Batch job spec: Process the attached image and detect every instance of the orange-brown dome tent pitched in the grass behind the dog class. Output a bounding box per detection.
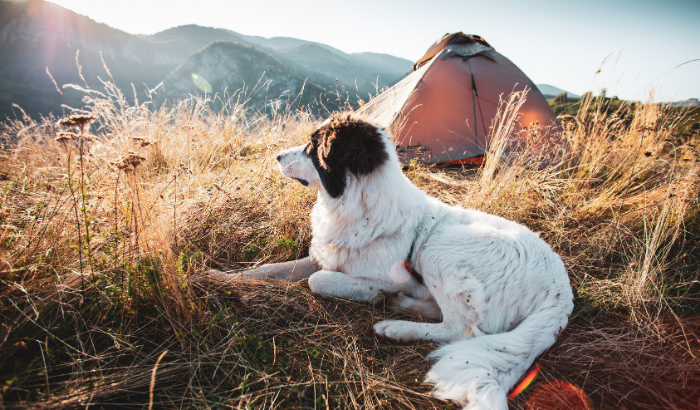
[358,32,560,164]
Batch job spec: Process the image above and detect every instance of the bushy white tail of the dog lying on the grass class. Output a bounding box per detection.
[425,301,573,410]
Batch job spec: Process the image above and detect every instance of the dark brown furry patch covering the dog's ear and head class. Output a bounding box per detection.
[306,114,389,198]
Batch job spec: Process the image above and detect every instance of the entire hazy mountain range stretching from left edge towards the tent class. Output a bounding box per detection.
[0,0,412,121]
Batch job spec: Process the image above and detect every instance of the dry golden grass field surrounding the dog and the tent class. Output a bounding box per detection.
[0,78,700,409]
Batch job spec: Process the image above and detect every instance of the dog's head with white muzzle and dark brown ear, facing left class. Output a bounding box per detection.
[277,114,389,198]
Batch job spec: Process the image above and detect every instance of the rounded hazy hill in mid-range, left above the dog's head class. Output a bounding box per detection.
[163,41,323,108]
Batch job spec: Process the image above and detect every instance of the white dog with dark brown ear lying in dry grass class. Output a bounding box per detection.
[246,114,573,409]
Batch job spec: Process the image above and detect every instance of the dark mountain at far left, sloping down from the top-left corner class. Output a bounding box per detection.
[0,0,178,118]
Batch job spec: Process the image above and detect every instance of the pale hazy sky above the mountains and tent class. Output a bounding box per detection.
[53,0,700,101]
